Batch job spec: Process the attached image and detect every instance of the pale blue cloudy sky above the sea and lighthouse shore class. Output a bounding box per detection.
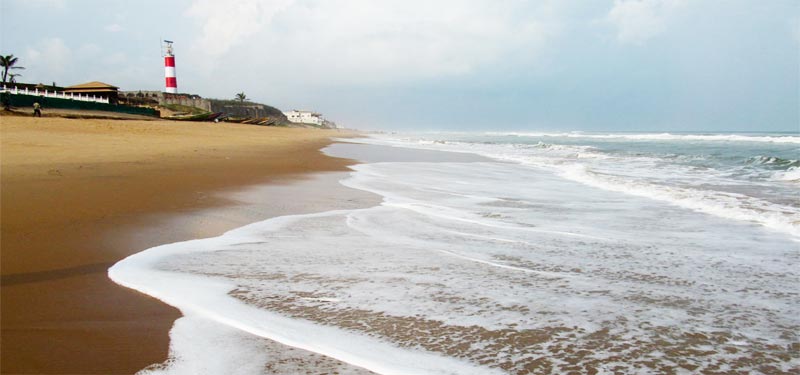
[0,0,800,132]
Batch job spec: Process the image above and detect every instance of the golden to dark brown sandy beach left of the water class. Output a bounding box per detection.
[0,116,358,374]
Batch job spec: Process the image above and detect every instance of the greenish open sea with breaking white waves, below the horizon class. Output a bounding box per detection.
[344,133,800,238]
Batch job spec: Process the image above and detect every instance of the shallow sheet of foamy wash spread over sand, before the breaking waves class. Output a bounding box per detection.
[109,142,800,374]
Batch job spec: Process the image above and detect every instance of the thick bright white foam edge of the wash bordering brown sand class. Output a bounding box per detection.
[108,210,501,375]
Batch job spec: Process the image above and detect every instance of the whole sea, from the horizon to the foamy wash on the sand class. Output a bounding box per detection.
[109,133,800,374]
